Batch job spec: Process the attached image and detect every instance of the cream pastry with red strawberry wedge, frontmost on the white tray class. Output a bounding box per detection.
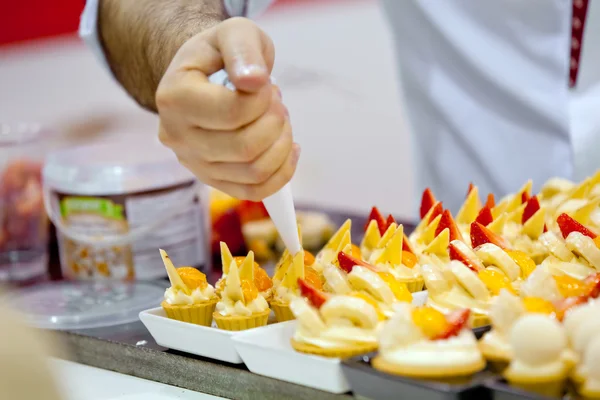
[290,279,382,358]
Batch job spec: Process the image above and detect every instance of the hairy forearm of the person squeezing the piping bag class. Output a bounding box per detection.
[98,0,225,111]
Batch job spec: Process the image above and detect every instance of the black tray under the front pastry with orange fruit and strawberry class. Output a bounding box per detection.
[342,353,492,400]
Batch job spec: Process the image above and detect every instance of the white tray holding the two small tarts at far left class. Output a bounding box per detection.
[140,307,246,364]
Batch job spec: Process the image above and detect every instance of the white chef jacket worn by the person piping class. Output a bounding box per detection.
[81,0,600,211]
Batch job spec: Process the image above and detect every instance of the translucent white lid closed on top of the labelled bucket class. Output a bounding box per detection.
[43,138,195,196]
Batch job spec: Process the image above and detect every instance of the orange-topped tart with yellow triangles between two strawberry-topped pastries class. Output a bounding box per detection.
[369,223,425,293]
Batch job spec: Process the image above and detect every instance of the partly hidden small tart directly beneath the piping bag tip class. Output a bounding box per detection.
[269,251,308,322]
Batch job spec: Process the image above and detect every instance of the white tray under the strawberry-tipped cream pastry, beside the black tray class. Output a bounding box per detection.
[232,291,427,393]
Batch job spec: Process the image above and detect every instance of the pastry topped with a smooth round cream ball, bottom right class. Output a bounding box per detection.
[504,314,571,397]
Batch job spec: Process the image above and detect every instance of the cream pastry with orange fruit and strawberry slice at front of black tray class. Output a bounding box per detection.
[372,304,485,381]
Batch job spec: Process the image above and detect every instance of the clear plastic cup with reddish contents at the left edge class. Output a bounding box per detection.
[0,123,49,282]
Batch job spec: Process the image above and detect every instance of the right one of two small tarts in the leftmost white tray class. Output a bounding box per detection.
[213,251,271,331]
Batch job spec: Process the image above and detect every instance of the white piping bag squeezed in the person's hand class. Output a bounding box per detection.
[208,69,302,255]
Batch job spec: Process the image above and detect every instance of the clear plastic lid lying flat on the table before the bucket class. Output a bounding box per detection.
[7,282,166,330]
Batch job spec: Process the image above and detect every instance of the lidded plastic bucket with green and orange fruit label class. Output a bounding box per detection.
[43,140,209,280]
